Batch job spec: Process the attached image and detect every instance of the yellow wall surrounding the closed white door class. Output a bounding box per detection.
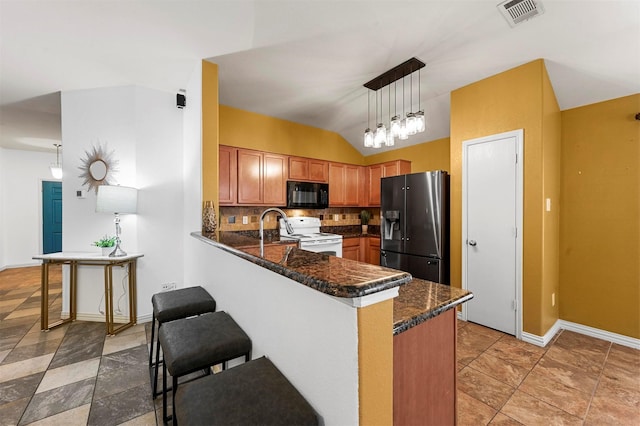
[450,60,557,335]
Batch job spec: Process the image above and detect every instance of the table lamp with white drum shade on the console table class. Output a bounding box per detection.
[96,185,138,257]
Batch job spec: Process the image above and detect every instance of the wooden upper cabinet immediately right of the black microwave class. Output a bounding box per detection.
[329,163,365,207]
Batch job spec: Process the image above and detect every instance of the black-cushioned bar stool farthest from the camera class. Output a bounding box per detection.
[149,286,216,399]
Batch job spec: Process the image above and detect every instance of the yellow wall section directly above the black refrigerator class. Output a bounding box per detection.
[365,138,449,173]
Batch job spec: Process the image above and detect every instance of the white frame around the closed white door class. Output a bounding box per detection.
[460,129,524,340]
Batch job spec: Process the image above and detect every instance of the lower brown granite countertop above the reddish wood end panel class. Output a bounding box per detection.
[393,278,473,335]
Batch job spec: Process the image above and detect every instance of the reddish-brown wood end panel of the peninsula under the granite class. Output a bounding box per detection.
[393,309,457,426]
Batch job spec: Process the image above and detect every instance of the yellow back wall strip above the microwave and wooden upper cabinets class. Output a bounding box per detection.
[220,105,364,164]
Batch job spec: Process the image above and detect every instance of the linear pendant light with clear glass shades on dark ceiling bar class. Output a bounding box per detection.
[364,58,425,148]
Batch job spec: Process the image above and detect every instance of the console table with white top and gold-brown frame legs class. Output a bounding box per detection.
[33,252,144,335]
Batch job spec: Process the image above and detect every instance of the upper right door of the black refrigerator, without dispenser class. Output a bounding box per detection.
[404,171,448,258]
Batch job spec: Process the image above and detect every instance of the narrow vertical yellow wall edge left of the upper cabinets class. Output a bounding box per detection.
[202,61,220,209]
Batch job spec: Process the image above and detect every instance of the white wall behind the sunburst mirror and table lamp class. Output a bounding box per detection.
[61,86,183,319]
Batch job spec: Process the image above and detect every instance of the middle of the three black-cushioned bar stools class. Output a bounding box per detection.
[158,311,251,423]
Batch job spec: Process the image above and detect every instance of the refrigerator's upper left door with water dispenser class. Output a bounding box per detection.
[380,176,406,252]
